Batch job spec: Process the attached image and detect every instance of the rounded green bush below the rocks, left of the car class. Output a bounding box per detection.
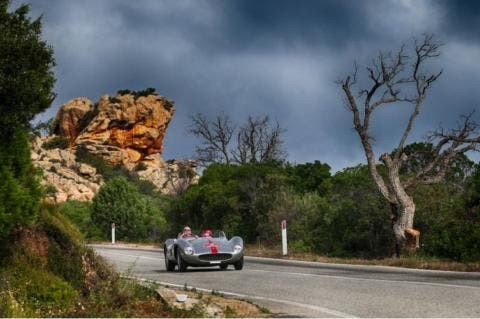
[91,177,165,241]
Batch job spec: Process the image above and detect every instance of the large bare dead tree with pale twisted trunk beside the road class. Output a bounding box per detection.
[338,35,480,255]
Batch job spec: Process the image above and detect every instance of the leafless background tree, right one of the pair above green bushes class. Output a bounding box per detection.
[233,116,286,164]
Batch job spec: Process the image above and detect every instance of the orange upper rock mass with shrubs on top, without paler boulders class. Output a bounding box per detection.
[57,94,175,165]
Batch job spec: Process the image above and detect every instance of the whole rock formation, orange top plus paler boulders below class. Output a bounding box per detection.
[32,91,198,202]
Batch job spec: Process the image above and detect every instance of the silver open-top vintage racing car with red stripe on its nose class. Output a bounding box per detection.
[163,231,243,272]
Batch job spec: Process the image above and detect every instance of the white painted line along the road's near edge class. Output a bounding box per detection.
[125,276,358,318]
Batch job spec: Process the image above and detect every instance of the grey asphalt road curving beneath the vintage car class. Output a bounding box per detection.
[93,245,480,317]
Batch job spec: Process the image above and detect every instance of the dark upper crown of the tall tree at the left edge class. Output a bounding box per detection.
[0,1,55,136]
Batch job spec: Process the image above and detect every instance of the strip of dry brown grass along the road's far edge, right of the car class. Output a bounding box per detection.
[245,245,480,271]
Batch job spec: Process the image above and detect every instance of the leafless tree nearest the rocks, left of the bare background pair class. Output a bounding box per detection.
[188,113,236,166]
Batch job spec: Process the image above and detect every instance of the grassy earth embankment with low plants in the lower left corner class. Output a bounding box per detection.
[0,204,182,317]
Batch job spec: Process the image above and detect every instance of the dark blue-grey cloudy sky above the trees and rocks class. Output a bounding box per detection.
[11,0,480,170]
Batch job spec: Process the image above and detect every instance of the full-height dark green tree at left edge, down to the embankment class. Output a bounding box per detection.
[0,0,55,238]
